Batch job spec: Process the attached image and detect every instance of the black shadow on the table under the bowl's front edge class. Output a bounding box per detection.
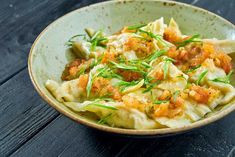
[83,114,235,156]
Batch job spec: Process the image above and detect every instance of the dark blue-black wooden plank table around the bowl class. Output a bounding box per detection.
[0,0,235,157]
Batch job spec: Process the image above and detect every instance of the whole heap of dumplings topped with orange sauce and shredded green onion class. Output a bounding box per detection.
[45,18,235,129]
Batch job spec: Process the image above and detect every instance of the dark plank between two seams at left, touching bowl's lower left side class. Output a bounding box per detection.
[0,69,58,156]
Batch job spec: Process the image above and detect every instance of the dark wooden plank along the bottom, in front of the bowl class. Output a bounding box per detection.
[9,113,235,157]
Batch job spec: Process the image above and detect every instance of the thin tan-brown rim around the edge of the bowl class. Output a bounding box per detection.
[28,0,235,135]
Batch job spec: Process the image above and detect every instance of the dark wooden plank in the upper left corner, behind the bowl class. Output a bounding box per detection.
[0,0,103,85]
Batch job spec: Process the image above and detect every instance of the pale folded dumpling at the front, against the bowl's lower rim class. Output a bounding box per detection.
[65,101,162,129]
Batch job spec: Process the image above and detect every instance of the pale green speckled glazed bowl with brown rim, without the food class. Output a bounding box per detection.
[28,0,235,136]
